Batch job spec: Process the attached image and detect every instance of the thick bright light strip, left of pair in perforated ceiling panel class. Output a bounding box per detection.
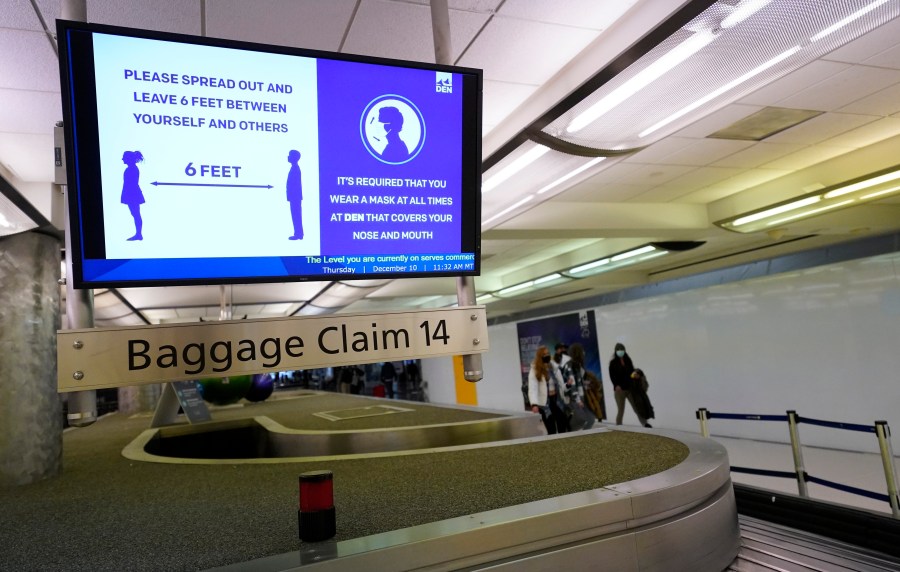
[566,31,716,133]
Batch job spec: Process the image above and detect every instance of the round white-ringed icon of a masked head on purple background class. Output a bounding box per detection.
[359,95,425,165]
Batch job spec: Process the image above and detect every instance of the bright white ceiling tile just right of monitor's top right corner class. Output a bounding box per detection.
[459,16,598,84]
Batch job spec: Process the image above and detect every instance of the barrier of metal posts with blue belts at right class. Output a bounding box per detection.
[697,407,900,519]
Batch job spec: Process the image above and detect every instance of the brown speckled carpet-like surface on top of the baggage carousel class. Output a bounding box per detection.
[0,394,687,571]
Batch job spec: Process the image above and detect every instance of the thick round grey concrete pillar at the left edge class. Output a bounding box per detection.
[0,232,63,486]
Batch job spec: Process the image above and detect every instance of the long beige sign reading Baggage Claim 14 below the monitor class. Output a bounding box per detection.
[57,306,488,392]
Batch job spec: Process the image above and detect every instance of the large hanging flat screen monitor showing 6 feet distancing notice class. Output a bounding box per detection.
[57,21,482,288]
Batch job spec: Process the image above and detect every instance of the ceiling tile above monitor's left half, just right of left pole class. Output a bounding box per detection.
[87,0,200,35]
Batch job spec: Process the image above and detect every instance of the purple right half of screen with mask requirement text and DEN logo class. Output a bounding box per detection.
[317,60,462,255]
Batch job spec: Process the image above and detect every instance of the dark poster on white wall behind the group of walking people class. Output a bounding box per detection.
[516,310,606,419]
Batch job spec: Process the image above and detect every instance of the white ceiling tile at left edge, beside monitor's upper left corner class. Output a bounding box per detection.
[0,29,59,92]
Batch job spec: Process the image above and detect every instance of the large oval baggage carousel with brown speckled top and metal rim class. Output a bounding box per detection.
[0,392,740,572]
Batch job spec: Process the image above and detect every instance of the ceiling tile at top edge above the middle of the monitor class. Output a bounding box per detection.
[206,0,356,52]
